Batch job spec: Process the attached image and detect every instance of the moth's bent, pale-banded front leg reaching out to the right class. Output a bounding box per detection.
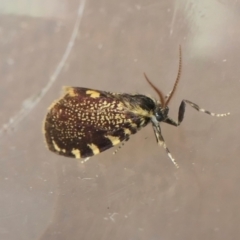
[164,99,230,126]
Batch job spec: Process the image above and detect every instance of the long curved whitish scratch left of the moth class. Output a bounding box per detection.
[0,0,86,136]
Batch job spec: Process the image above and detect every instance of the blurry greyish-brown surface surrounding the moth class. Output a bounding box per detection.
[0,0,240,240]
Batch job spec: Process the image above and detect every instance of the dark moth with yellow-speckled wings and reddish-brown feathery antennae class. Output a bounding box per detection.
[44,48,230,167]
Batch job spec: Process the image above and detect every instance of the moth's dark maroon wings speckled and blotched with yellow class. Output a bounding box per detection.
[44,87,150,158]
